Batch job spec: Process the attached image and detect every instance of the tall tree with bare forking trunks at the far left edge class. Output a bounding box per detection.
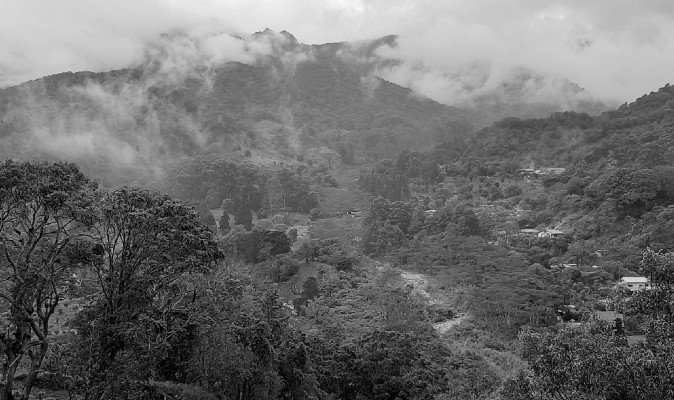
[0,161,96,400]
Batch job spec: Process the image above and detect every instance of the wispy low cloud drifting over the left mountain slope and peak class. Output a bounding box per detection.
[0,27,320,183]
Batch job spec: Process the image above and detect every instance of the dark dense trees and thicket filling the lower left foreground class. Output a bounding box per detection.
[0,161,498,399]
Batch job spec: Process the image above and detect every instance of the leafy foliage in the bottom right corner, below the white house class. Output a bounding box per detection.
[505,250,674,399]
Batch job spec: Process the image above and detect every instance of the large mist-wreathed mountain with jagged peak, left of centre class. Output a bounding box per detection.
[0,30,474,186]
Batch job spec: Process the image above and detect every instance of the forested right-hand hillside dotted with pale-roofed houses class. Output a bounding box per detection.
[350,86,674,399]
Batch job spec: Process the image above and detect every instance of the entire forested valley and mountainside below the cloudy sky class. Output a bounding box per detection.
[0,24,674,400]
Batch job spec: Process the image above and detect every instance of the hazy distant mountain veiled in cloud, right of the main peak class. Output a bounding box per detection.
[374,38,614,126]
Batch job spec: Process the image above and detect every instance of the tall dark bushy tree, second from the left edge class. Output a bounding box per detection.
[73,188,220,396]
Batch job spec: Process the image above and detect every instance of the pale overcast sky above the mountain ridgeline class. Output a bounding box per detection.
[0,0,674,102]
